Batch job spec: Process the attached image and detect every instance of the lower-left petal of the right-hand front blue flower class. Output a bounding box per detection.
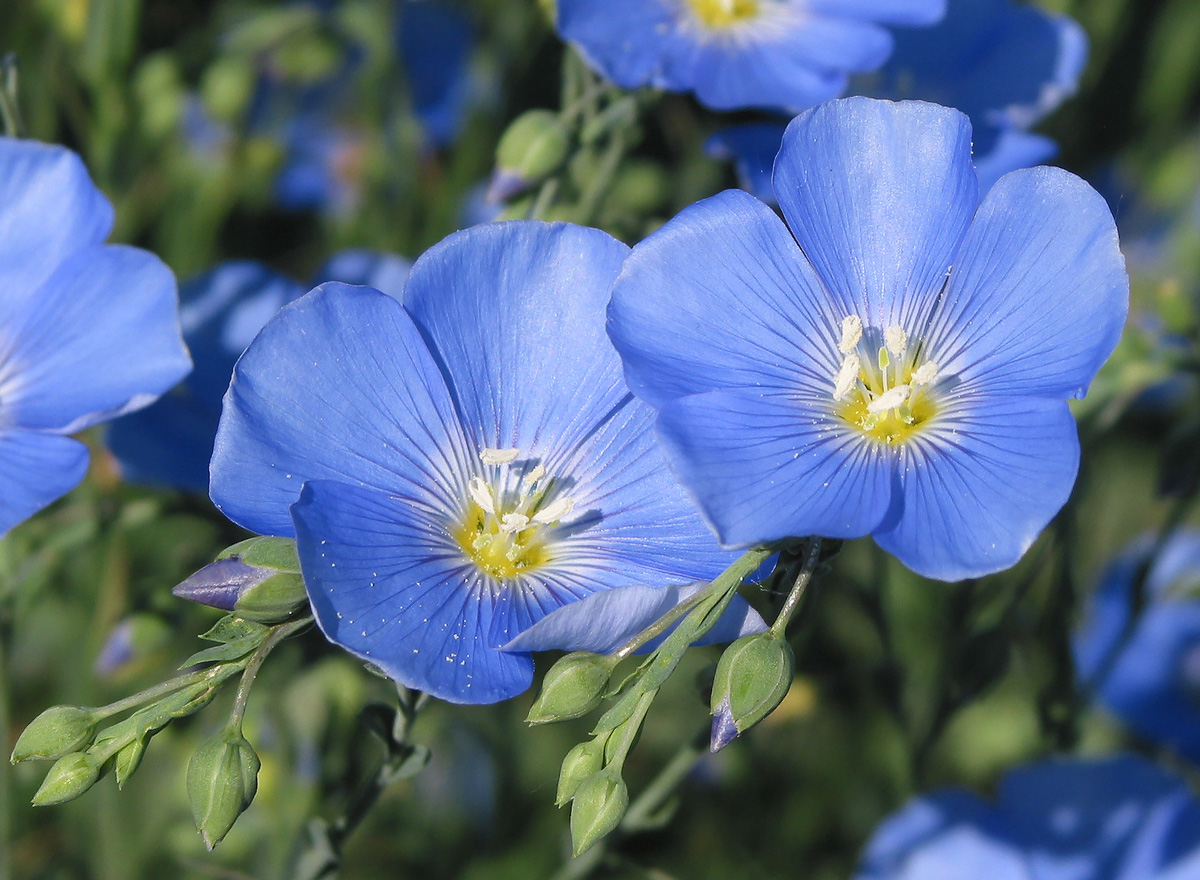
[659,391,892,546]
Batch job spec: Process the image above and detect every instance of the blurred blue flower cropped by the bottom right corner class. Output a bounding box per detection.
[854,755,1200,880]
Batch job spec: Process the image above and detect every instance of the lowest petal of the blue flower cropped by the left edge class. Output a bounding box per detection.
[0,430,88,535]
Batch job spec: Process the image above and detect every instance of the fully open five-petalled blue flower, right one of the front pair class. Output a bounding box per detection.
[608,98,1128,580]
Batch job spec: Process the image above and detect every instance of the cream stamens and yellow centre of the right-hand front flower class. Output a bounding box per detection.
[833,315,938,445]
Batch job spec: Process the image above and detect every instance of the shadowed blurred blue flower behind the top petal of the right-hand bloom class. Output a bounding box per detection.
[707,0,1087,204]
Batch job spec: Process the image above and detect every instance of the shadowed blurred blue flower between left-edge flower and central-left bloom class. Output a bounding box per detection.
[107,250,408,492]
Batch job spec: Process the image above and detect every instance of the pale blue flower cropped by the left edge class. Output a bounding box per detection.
[0,138,191,534]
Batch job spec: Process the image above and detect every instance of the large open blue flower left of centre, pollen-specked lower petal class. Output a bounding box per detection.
[211,222,732,702]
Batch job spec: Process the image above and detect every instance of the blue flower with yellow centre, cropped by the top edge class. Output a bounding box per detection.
[558,0,946,112]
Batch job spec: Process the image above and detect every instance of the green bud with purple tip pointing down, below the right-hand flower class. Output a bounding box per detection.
[709,629,796,752]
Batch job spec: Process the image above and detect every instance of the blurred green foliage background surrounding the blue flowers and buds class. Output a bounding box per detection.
[7,0,1200,880]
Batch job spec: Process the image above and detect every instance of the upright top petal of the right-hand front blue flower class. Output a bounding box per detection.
[774,98,977,328]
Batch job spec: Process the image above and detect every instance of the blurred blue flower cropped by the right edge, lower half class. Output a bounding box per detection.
[1075,532,1200,762]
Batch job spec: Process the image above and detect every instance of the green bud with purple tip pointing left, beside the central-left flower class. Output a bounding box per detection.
[170,538,307,623]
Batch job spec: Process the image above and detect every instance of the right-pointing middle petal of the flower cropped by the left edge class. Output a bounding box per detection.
[0,245,191,433]
